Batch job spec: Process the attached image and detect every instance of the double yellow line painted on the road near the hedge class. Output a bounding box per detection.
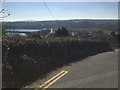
[35,70,68,90]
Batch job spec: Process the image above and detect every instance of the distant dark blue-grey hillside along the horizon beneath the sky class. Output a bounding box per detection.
[2,19,118,31]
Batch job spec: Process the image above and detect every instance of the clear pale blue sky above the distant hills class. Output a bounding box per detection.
[2,2,118,21]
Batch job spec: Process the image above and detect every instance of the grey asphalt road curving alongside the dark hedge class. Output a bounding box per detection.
[27,50,118,88]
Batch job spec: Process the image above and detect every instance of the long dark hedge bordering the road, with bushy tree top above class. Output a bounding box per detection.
[2,27,118,88]
